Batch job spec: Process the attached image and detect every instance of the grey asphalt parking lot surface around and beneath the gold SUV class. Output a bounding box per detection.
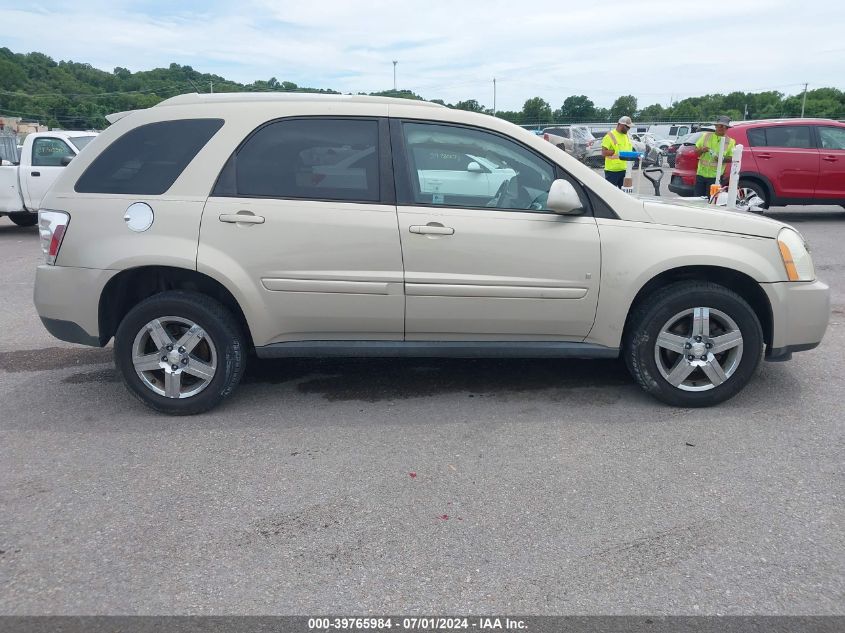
[0,178,845,615]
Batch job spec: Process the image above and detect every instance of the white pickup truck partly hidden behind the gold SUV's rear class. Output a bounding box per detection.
[0,130,97,226]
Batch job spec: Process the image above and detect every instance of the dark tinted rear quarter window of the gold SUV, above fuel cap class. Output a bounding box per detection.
[75,119,223,195]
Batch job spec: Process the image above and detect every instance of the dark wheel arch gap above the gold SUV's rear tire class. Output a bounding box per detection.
[98,266,253,348]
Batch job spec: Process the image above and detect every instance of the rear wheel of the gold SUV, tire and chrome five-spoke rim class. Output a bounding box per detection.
[114,291,245,415]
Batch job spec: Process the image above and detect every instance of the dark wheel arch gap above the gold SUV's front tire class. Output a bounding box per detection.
[622,266,774,346]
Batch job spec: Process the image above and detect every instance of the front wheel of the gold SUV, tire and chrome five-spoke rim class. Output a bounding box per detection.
[624,282,763,407]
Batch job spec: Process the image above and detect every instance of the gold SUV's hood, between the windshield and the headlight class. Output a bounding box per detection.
[643,198,787,239]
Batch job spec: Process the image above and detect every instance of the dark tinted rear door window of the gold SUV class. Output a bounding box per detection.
[229,119,379,202]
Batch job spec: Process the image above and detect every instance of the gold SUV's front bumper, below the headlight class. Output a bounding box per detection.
[760,281,830,360]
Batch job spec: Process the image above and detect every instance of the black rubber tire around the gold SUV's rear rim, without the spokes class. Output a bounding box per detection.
[114,290,247,415]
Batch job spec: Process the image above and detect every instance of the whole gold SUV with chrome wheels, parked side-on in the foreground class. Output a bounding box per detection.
[35,94,829,415]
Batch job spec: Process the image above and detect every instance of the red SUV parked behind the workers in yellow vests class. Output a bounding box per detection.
[669,119,845,208]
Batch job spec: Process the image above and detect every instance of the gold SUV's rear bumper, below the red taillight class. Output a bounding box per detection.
[34,264,120,346]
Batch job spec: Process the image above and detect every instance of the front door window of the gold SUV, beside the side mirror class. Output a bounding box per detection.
[402,123,554,211]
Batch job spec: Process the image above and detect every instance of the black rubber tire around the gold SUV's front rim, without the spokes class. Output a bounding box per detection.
[623,281,763,407]
